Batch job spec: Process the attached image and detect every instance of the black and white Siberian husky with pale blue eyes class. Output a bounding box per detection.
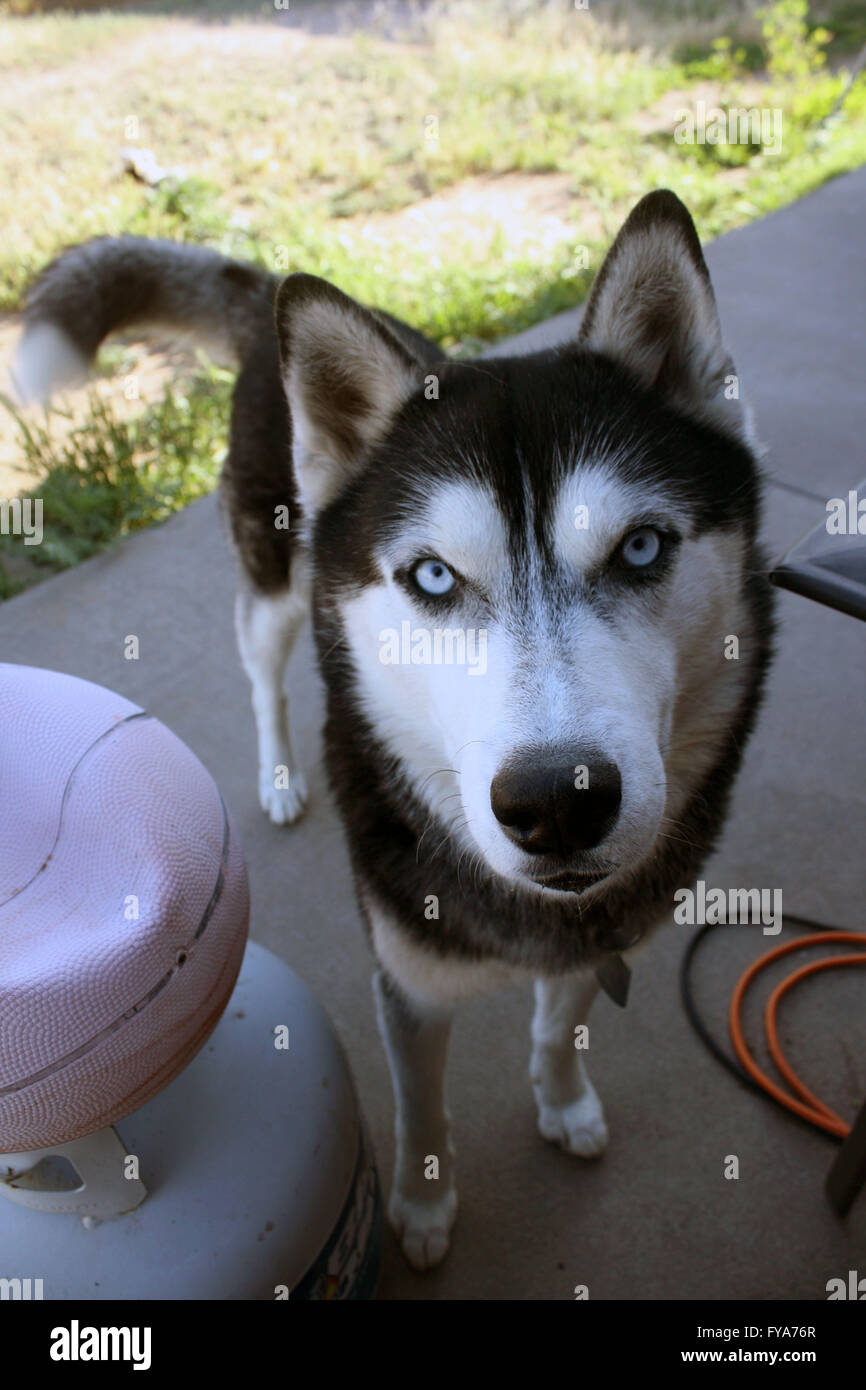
[17,192,773,1269]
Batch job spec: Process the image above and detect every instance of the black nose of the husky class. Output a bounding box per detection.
[491,749,623,859]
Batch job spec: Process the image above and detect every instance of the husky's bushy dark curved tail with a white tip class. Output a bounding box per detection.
[11,236,279,403]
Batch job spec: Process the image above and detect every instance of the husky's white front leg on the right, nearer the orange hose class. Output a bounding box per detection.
[530,974,607,1158]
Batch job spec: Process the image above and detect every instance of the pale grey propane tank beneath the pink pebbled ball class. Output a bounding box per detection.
[0,942,384,1300]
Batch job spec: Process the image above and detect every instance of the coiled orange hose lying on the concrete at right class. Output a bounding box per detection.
[728,931,866,1138]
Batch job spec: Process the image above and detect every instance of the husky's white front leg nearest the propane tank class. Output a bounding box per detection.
[373,967,457,1269]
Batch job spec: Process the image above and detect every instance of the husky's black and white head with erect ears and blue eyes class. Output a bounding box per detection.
[277,192,758,894]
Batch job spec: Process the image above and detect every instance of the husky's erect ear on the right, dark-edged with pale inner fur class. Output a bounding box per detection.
[578,189,752,443]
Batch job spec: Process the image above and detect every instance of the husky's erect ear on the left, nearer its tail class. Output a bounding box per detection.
[277,274,423,516]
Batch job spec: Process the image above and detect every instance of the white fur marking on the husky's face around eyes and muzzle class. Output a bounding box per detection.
[335,467,748,897]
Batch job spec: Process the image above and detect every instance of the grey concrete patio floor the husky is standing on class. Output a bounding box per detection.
[0,170,866,1300]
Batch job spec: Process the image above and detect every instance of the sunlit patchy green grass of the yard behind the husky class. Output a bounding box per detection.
[0,0,866,592]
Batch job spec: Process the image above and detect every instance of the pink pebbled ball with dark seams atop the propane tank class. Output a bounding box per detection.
[0,663,249,1154]
